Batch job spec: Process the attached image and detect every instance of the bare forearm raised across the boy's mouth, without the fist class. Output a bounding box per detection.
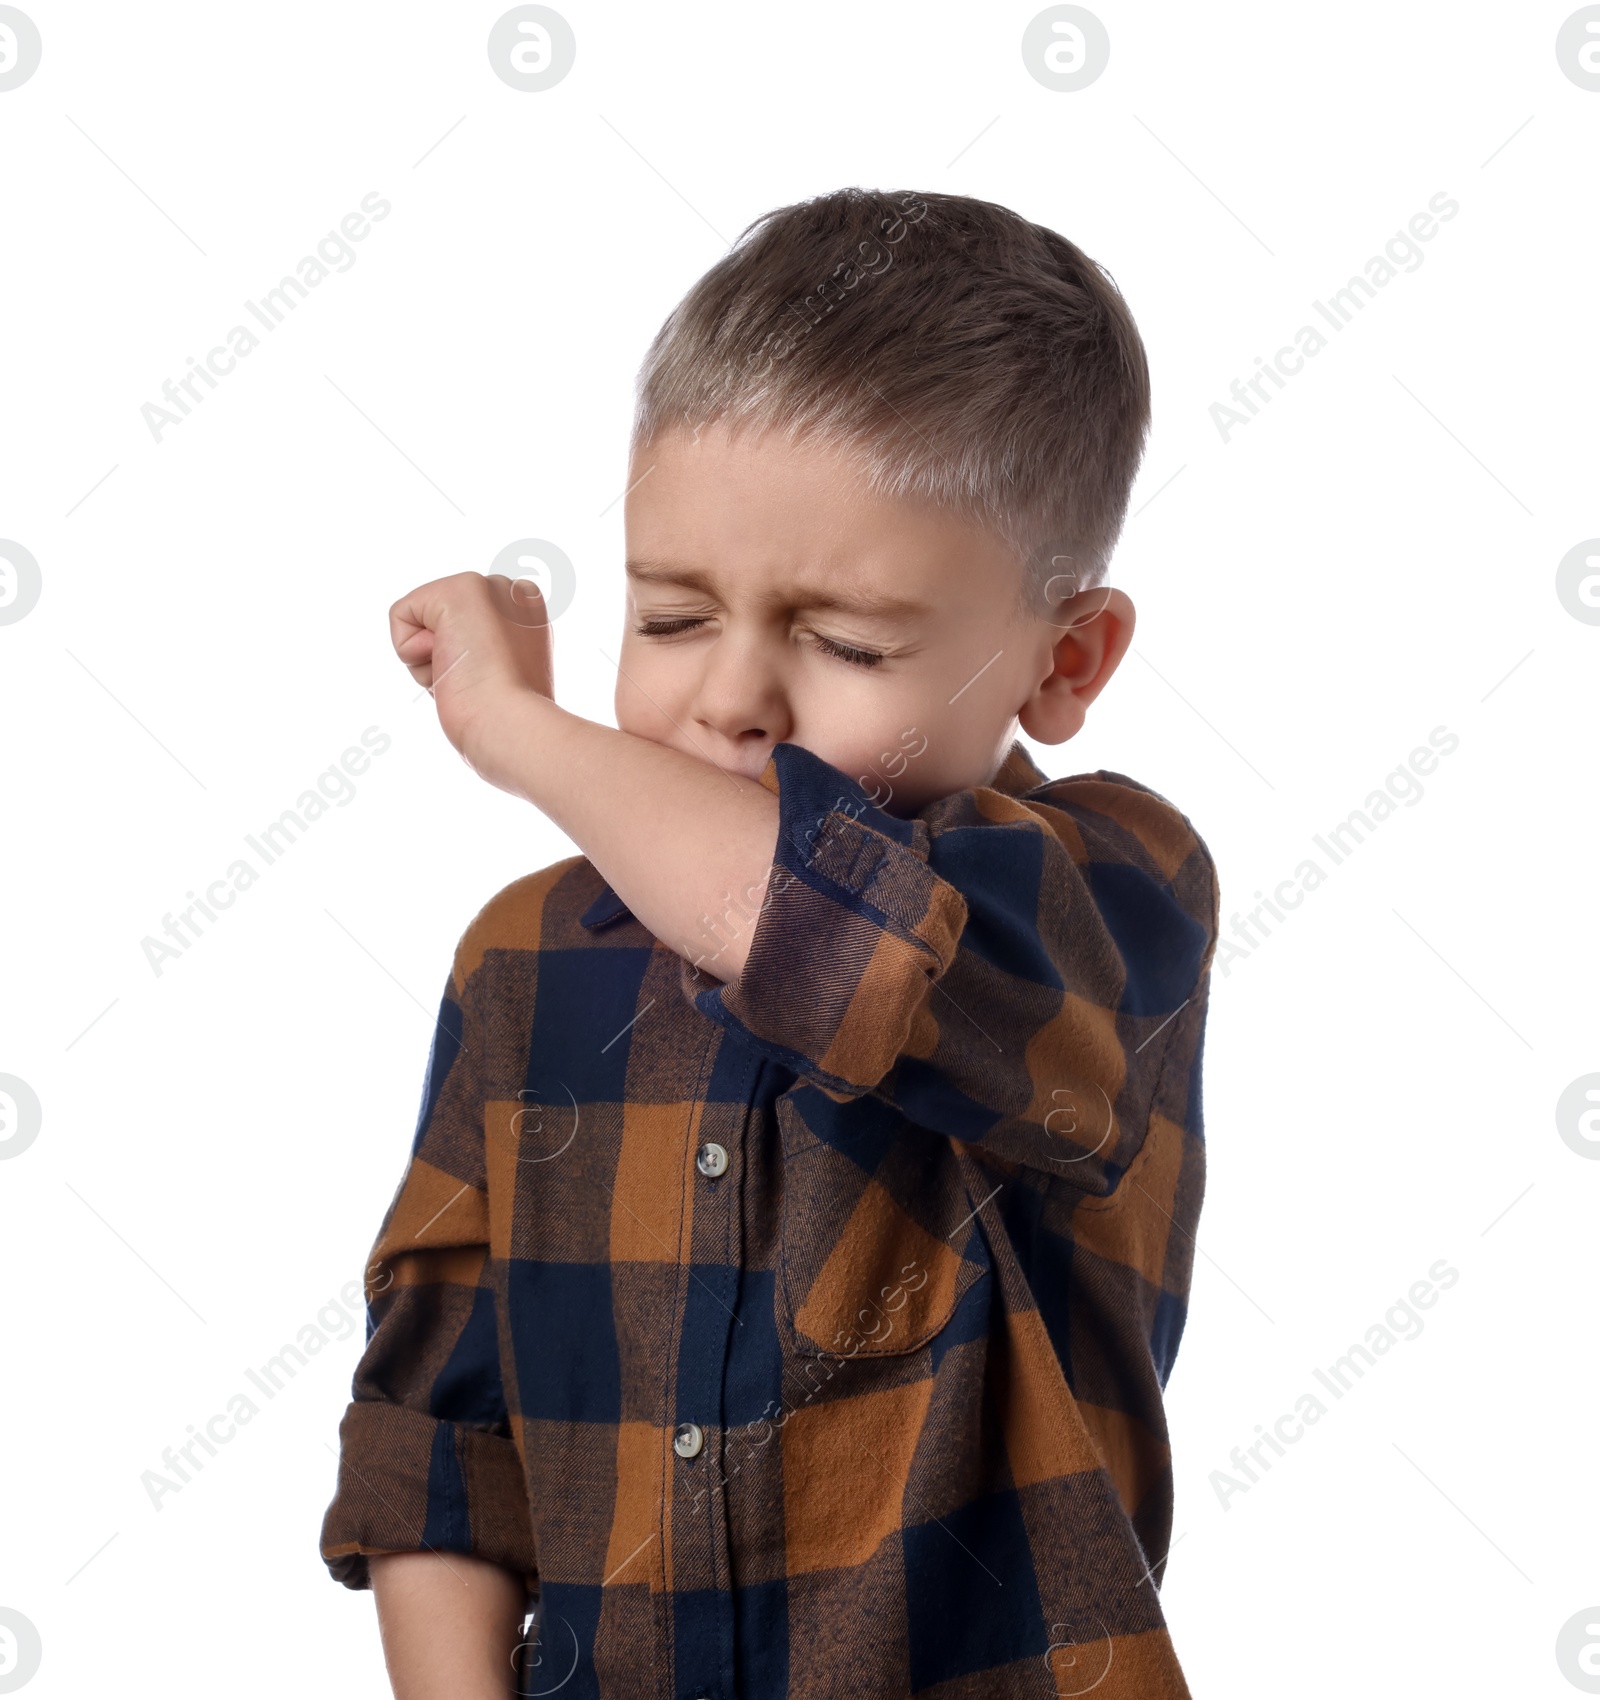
[473,692,779,981]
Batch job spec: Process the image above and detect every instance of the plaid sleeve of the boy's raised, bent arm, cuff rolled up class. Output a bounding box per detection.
[684,743,1217,1193]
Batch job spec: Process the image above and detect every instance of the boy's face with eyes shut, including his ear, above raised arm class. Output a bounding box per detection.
[616,425,1132,814]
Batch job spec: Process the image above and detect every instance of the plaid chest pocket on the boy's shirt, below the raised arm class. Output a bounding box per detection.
[777,1095,990,1357]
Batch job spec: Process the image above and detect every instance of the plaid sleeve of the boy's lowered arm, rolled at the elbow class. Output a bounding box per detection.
[321,952,537,1590]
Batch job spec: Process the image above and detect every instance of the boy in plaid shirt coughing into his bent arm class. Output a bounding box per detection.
[321,189,1217,1700]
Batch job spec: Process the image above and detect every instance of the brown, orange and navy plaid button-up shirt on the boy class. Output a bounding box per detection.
[321,743,1217,1700]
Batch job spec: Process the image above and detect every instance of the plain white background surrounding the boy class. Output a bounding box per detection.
[0,0,1600,1700]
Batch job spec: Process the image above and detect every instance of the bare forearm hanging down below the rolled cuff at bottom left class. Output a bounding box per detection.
[367,1552,525,1700]
